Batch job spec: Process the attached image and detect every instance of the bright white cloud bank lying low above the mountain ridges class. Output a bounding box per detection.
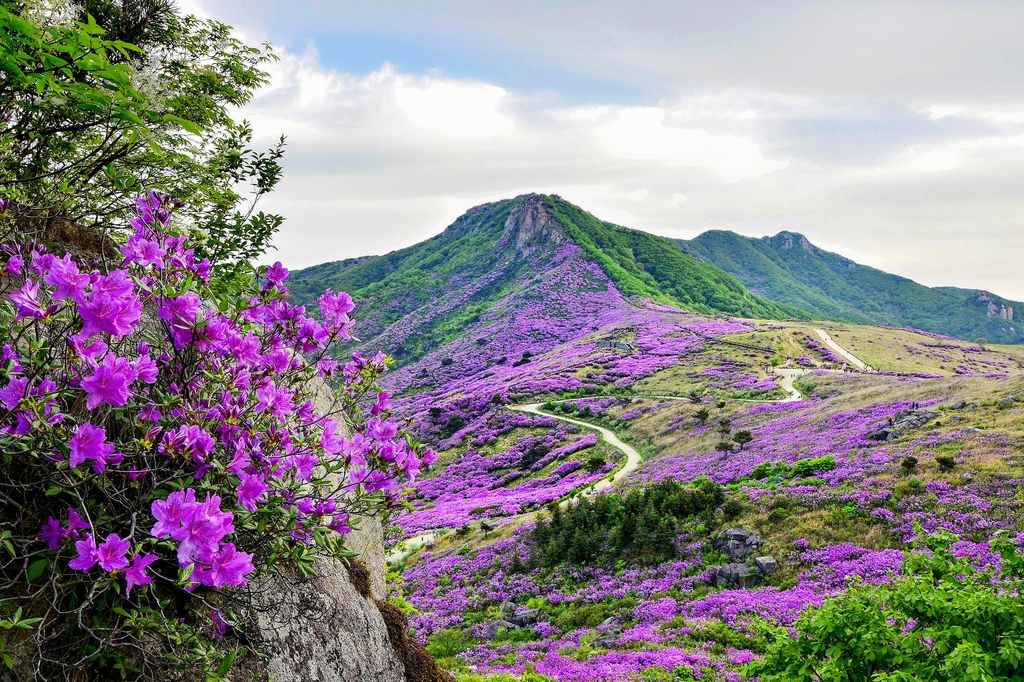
[234,41,1024,299]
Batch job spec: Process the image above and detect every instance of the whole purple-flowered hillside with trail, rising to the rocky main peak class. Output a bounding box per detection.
[293,196,1024,682]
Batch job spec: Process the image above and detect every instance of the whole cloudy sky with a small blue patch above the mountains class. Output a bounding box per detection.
[179,0,1024,300]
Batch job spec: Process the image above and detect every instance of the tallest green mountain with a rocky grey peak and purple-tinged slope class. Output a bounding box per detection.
[289,195,803,376]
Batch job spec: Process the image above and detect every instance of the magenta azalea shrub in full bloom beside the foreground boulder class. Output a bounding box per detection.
[0,194,434,679]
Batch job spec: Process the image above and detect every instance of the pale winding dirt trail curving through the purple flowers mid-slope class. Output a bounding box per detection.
[387,369,805,562]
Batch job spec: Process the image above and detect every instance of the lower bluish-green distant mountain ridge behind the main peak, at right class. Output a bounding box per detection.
[673,230,1024,343]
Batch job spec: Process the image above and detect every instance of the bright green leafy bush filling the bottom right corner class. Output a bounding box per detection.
[744,535,1024,682]
